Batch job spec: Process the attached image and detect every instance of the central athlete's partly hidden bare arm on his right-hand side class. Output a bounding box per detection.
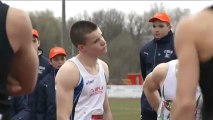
[102,61,112,120]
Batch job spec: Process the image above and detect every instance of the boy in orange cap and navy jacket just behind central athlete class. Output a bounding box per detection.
[36,47,67,120]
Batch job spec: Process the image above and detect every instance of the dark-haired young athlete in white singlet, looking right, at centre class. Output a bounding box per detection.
[56,21,112,120]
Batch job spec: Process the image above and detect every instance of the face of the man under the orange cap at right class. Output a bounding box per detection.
[152,20,171,39]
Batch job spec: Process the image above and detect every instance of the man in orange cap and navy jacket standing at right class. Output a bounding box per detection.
[140,12,177,120]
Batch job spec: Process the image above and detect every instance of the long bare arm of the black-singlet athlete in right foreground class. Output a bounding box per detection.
[171,16,199,120]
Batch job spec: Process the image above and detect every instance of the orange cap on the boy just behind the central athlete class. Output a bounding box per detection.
[49,47,67,59]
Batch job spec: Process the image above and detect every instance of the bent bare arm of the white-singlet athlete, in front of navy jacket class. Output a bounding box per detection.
[143,63,168,111]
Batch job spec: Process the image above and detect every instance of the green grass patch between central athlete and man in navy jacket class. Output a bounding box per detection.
[109,98,140,120]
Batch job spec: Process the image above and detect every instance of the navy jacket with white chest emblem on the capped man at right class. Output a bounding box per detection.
[140,31,177,111]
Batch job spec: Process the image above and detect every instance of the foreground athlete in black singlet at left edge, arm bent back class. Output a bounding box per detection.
[0,1,38,120]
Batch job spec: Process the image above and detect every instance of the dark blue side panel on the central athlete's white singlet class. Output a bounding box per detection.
[70,76,84,120]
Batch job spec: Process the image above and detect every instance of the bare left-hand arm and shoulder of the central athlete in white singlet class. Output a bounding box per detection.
[56,61,80,120]
